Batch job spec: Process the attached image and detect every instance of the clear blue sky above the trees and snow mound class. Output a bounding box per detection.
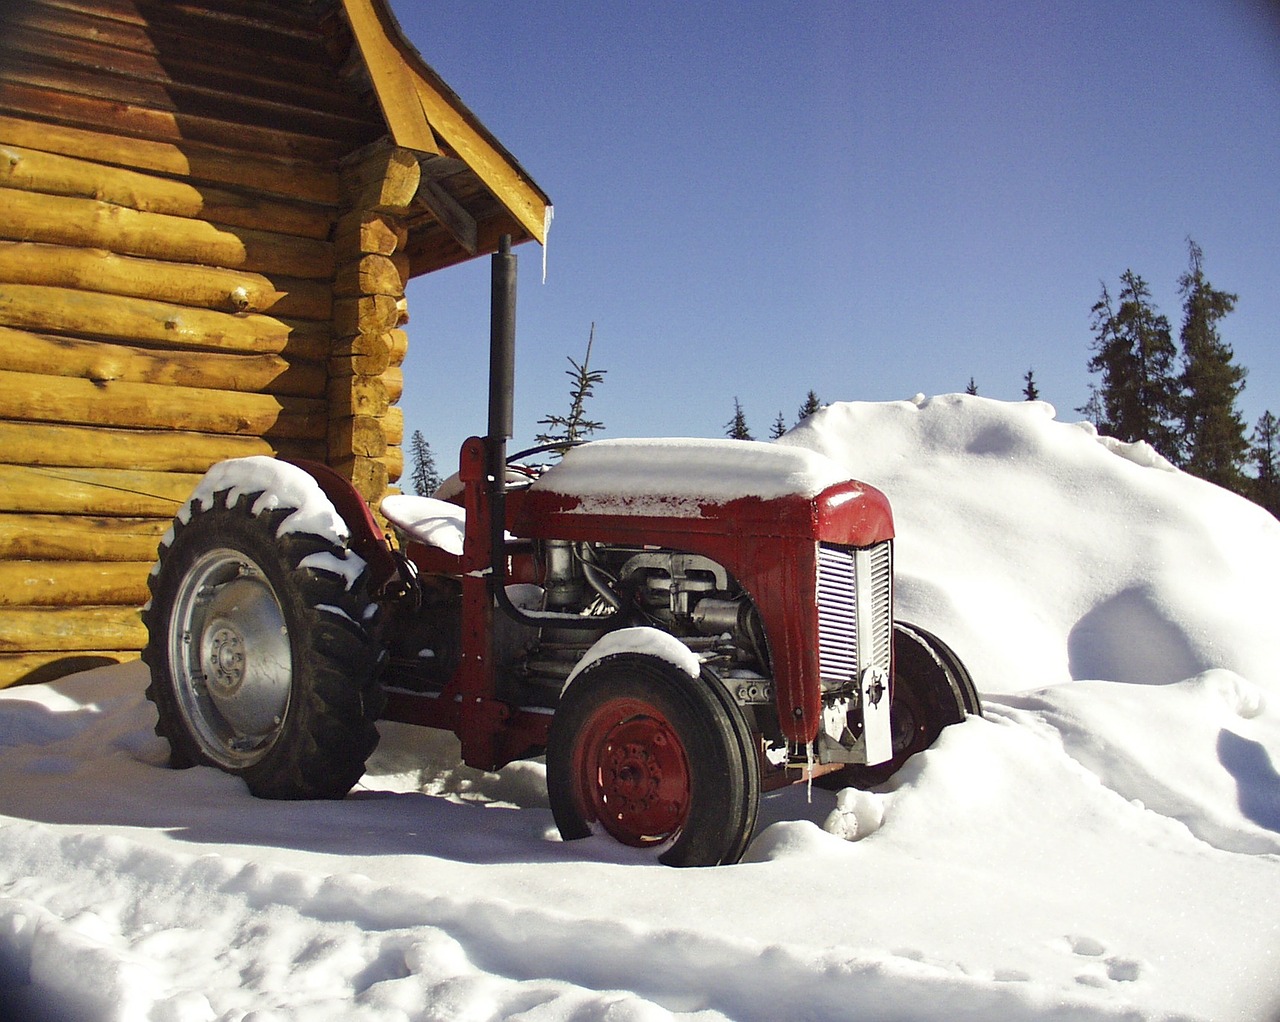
[392,0,1280,474]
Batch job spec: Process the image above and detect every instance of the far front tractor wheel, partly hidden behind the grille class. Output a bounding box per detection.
[823,621,982,788]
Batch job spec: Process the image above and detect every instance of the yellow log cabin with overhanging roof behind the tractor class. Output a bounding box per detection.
[0,0,552,686]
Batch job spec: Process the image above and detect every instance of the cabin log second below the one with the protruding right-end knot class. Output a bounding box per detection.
[0,327,328,397]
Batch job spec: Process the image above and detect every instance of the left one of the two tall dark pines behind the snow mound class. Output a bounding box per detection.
[1089,270,1180,464]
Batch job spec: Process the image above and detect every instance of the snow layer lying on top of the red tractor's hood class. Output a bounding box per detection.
[531,438,870,517]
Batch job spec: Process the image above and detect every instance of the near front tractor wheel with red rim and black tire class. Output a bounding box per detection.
[547,653,760,866]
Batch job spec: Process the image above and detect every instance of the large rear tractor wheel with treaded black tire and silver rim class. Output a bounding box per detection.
[142,489,384,799]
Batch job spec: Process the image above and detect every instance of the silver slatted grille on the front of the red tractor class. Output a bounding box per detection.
[818,542,893,692]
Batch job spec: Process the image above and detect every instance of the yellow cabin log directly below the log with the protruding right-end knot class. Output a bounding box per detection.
[0,283,330,360]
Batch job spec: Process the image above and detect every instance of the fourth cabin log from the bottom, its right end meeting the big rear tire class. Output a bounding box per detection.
[0,515,169,561]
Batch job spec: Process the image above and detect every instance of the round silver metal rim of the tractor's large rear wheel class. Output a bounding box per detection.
[169,549,293,770]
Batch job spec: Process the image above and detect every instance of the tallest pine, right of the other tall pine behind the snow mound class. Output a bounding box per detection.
[1178,238,1249,493]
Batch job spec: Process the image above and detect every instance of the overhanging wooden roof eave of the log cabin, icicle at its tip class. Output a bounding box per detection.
[342,0,552,274]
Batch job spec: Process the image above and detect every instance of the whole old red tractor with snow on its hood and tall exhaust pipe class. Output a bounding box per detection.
[143,241,979,866]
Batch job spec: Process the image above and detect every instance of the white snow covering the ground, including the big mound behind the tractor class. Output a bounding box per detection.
[0,396,1280,1022]
